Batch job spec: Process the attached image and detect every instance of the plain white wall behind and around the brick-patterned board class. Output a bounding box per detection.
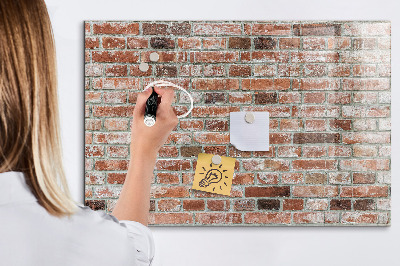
[46,0,400,266]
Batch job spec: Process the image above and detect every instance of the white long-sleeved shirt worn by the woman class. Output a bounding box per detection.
[0,171,154,266]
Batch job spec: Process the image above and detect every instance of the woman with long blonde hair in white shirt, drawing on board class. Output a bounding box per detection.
[0,0,178,266]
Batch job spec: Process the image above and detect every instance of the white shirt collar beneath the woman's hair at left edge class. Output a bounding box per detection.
[0,171,37,205]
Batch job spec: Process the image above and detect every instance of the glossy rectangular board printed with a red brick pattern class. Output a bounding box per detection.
[85,21,391,226]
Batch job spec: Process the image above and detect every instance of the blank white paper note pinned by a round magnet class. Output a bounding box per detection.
[229,112,269,151]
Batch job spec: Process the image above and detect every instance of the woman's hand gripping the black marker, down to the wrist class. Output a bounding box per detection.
[130,87,178,156]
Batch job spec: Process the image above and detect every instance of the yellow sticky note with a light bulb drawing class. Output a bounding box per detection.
[192,153,236,196]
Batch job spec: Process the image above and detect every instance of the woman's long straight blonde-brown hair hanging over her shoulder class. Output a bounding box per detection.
[0,0,76,216]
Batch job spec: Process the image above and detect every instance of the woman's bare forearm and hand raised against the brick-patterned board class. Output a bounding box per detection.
[112,87,178,225]
